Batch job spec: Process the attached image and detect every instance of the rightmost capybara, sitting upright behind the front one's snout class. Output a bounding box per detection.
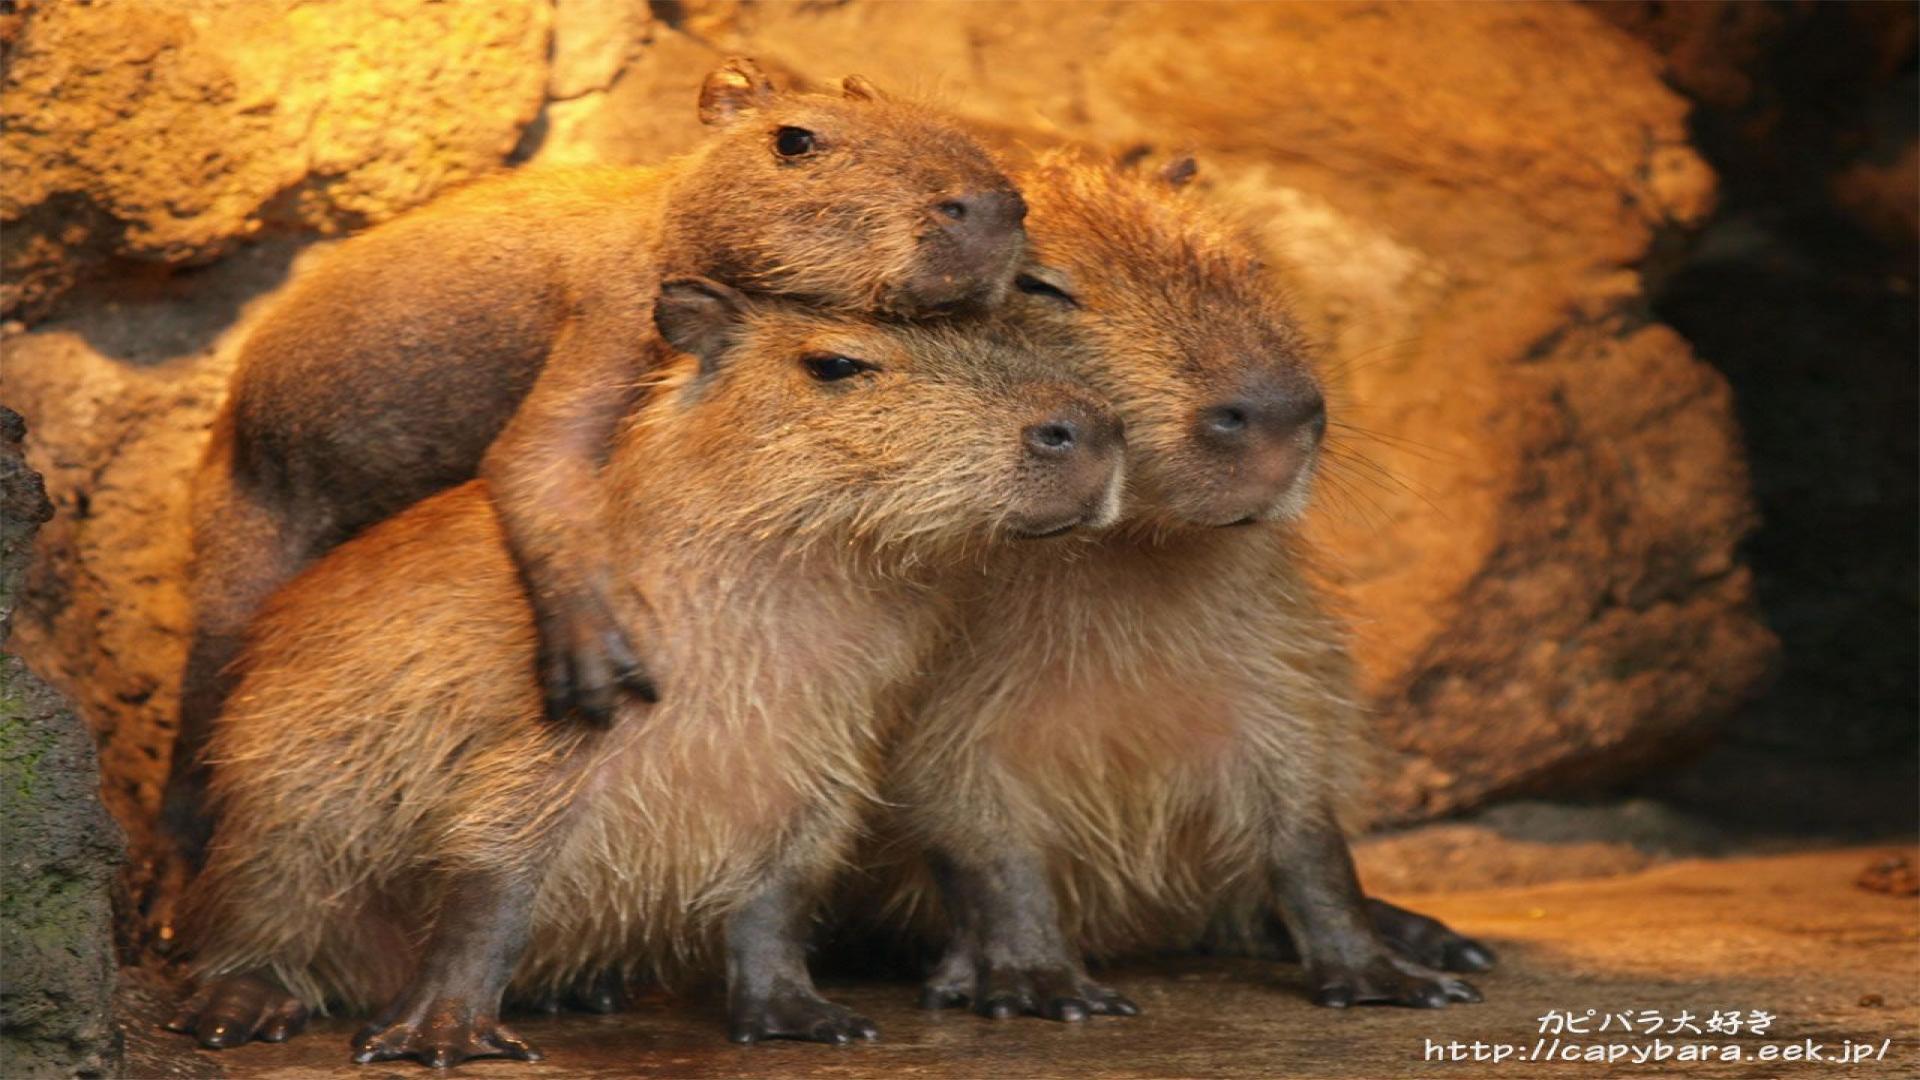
[866,154,1492,1019]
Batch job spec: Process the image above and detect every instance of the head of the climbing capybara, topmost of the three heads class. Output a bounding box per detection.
[668,60,1027,315]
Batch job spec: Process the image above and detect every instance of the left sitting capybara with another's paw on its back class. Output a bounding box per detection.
[175,279,1123,1065]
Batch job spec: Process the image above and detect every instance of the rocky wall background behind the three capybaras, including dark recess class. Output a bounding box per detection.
[0,0,1916,1068]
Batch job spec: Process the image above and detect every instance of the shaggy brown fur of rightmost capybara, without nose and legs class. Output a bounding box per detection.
[877,156,1365,959]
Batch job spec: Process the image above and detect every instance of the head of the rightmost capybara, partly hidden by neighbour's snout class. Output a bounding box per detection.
[1014,154,1327,527]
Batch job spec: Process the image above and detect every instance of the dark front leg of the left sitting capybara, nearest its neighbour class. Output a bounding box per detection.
[726,868,879,1043]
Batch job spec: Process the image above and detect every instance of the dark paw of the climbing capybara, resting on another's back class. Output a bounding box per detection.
[540,601,660,728]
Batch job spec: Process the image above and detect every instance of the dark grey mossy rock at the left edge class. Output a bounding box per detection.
[0,407,123,1076]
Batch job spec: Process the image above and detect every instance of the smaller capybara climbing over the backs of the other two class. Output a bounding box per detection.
[163,60,1025,865]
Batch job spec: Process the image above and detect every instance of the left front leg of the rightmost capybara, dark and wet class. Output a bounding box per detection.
[922,853,1140,1022]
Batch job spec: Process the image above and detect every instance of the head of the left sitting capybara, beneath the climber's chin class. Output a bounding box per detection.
[636,277,1125,550]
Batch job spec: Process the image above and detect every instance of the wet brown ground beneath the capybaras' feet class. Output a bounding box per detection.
[127,847,1920,1080]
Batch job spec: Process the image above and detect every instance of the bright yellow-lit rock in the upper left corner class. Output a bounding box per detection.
[0,0,549,317]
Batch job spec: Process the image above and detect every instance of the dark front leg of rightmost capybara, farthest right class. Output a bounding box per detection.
[1275,817,1480,1009]
